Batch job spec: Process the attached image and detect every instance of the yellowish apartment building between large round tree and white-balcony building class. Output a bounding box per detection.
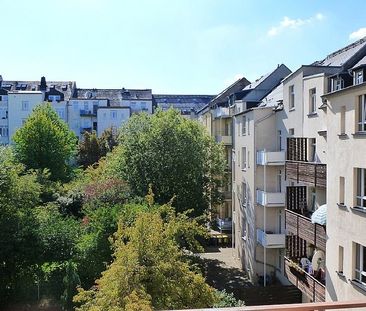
[196,78,250,232]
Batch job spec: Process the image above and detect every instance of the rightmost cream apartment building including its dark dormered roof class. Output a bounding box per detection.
[323,56,366,301]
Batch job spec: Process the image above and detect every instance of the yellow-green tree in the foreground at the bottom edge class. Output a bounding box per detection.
[74,206,217,311]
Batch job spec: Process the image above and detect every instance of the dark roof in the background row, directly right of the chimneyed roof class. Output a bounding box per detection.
[74,88,152,106]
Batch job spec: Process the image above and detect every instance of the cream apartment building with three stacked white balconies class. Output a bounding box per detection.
[230,64,291,285]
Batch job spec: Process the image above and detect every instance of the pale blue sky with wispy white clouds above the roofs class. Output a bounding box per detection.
[0,0,366,95]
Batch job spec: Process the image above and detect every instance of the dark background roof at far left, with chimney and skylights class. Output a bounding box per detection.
[0,80,76,100]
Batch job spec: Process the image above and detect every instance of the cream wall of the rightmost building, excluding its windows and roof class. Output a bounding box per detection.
[327,85,366,301]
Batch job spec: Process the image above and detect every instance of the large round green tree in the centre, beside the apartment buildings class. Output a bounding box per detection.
[109,109,225,215]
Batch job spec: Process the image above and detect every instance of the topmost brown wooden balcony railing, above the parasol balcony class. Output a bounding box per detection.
[285,161,327,187]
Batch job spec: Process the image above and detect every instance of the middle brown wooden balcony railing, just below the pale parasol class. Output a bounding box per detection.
[286,210,327,251]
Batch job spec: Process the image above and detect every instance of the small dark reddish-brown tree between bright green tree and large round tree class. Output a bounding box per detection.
[78,131,101,168]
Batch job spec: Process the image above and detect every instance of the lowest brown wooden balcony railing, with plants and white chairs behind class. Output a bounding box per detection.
[285,257,325,304]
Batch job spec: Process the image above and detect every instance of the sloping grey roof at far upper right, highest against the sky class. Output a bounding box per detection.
[312,37,366,66]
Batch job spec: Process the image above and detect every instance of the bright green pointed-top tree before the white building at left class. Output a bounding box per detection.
[13,103,76,180]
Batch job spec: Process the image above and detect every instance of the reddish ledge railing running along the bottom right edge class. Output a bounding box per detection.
[171,299,366,311]
